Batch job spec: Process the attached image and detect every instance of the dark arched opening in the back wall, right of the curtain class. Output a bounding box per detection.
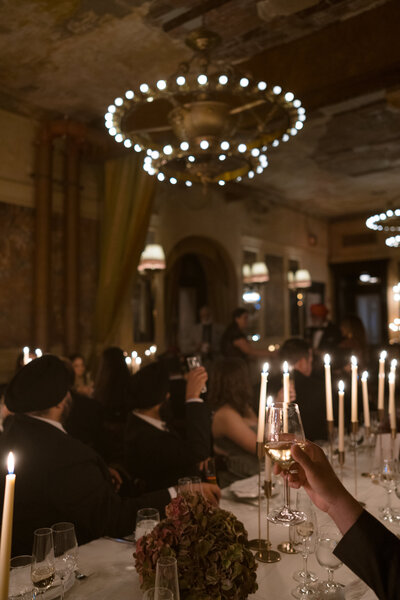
[165,236,237,347]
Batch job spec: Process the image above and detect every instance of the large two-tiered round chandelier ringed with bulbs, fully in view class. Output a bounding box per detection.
[105,29,306,187]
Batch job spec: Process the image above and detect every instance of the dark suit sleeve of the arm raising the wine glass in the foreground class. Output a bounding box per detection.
[335,511,400,600]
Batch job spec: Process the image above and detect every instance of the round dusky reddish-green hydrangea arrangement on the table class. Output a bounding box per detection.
[133,494,258,600]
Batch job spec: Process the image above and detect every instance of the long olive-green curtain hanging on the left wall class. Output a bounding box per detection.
[94,153,155,354]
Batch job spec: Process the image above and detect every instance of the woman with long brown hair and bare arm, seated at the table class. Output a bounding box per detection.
[208,357,258,487]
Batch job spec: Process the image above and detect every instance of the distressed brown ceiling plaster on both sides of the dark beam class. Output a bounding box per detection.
[0,0,400,217]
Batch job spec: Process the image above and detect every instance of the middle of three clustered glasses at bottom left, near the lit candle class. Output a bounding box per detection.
[31,527,55,594]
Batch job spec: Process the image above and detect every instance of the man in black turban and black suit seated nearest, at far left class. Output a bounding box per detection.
[0,354,219,555]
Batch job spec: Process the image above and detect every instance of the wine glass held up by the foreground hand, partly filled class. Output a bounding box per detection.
[264,402,306,525]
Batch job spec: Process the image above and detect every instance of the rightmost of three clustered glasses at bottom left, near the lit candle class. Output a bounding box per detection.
[51,523,78,585]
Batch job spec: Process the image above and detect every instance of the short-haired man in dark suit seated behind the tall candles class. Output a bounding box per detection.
[280,338,327,441]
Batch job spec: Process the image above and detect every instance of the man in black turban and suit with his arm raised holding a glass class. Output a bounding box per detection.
[125,363,211,491]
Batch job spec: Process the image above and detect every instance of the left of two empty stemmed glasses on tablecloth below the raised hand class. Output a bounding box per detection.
[292,493,318,598]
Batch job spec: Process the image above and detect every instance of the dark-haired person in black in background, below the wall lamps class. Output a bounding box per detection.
[221,308,271,360]
